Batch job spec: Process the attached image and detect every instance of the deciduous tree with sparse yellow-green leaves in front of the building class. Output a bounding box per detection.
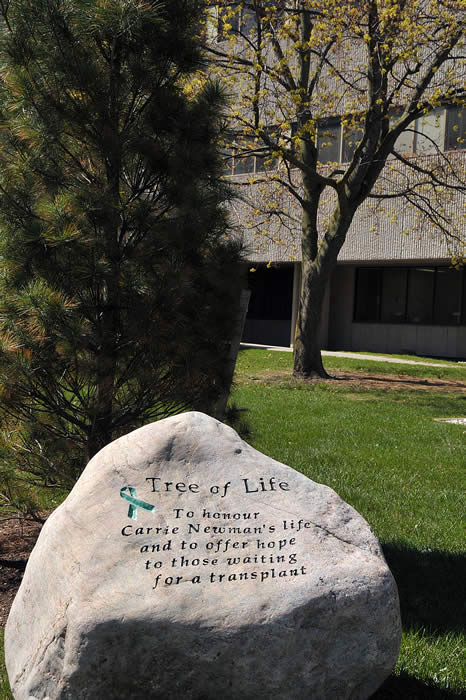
[208,0,466,377]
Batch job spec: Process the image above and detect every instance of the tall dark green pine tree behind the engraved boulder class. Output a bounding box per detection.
[0,0,239,516]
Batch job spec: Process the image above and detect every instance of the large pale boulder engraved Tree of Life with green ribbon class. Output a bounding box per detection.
[5,413,400,700]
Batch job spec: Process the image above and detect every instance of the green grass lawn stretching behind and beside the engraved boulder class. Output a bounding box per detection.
[0,349,466,700]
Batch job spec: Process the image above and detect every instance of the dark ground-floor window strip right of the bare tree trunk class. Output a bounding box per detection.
[354,266,466,326]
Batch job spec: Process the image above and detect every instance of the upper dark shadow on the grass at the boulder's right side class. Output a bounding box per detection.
[383,542,466,633]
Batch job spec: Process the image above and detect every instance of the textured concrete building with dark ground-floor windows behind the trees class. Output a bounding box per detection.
[212,0,466,358]
